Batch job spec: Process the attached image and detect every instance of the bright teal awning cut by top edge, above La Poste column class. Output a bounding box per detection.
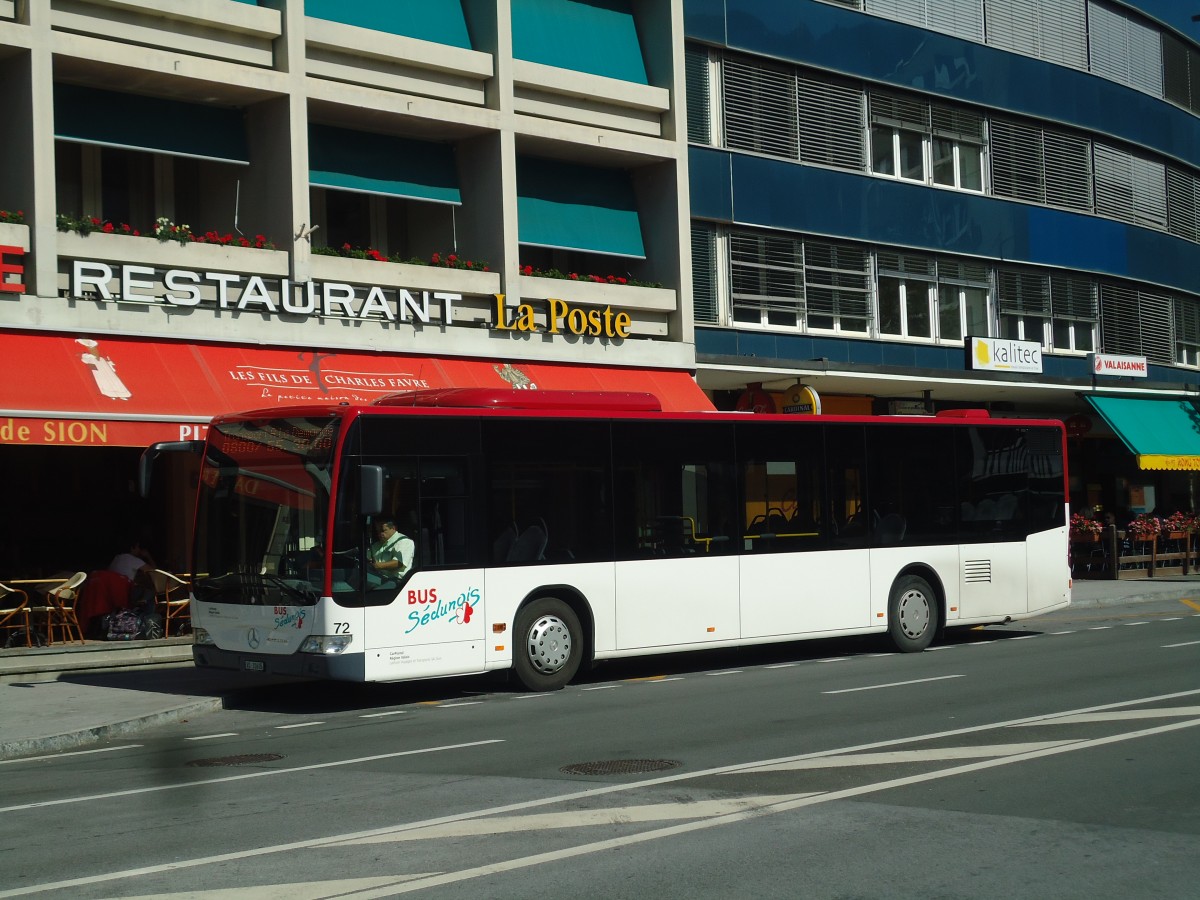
[511,0,648,84]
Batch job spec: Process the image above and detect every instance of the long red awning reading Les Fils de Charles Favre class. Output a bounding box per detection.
[0,331,713,446]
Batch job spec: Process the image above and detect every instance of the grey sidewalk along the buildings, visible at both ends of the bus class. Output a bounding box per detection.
[0,575,1200,760]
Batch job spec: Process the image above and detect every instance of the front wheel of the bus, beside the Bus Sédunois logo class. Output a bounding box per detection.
[512,596,583,691]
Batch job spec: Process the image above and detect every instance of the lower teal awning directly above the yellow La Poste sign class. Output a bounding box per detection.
[517,156,646,259]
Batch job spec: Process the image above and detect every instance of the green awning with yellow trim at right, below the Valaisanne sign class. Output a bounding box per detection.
[1087,396,1200,472]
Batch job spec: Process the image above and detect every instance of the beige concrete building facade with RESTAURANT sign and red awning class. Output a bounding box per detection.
[0,0,710,577]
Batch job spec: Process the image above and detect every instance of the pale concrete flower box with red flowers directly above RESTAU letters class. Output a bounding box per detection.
[58,232,288,277]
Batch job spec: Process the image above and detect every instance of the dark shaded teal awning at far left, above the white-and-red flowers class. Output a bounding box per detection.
[54,84,250,166]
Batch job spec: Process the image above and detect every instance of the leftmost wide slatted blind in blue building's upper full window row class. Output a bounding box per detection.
[722,59,798,160]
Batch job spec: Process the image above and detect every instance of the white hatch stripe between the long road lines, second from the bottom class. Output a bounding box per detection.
[336,791,821,847]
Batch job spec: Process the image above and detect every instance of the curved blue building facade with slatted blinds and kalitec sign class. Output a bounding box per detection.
[685,0,1200,512]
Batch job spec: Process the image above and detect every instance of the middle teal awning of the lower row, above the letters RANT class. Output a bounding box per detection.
[308,125,462,204]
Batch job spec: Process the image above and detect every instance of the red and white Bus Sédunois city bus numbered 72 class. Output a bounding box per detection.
[142,389,1070,691]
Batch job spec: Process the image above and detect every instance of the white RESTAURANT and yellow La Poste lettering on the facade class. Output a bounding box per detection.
[70,259,632,340]
